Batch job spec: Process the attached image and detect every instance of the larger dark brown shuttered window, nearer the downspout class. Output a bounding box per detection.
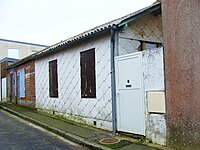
[80,49,96,98]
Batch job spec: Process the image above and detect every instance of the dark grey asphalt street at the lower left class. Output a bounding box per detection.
[0,110,84,150]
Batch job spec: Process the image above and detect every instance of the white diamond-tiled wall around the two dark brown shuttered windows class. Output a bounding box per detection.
[35,36,112,130]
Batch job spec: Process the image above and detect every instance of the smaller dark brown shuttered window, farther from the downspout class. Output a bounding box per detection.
[49,60,58,98]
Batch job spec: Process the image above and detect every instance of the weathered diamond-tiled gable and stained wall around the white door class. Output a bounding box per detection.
[117,7,166,145]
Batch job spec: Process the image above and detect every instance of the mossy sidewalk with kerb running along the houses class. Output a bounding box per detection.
[0,103,166,150]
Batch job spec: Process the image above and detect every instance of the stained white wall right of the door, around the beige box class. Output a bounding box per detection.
[143,48,166,145]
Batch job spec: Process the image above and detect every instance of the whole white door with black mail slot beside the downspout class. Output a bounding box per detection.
[116,52,145,135]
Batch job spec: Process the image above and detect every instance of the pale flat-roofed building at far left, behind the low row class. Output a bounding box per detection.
[0,39,47,101]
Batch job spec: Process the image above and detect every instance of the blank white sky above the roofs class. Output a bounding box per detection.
[0,0,155,45]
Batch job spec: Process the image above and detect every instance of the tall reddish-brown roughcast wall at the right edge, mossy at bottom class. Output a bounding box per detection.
[162,0,200,150]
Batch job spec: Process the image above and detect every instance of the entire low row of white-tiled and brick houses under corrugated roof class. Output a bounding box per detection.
[7,3,166,145]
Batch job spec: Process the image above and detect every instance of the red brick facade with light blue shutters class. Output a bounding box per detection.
[7,61,35,108]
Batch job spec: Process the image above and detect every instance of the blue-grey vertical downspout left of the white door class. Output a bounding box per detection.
[110,25,117,135]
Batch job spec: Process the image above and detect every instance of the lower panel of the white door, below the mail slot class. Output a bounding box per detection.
[119,90,145,135]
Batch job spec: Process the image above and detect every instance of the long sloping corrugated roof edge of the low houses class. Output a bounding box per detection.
[9,2,160,68]
